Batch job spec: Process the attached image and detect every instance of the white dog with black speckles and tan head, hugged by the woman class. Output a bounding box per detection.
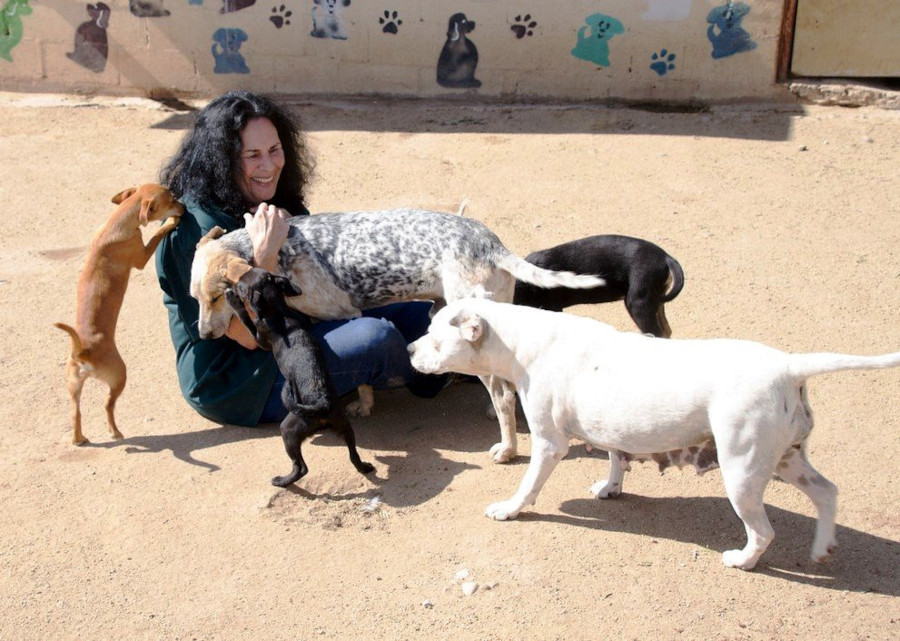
[191,209,604,463]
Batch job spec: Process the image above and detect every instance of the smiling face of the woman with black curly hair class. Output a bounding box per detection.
[240,118,284,205]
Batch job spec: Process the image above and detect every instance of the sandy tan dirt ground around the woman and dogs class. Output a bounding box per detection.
[0,93,900,641]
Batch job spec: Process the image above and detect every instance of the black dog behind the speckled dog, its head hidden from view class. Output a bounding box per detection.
[513,235,684,338]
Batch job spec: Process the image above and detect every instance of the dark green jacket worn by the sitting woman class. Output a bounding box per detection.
[156,196,308,426]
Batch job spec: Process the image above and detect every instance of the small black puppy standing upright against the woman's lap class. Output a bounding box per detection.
[225,268,375,487]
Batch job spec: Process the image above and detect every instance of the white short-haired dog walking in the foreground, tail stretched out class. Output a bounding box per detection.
[409,299,900,570]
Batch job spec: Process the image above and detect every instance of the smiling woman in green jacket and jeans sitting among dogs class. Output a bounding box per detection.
[156,91,445,426]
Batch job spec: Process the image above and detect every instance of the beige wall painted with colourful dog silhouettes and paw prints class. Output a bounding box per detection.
[0,0,783,102]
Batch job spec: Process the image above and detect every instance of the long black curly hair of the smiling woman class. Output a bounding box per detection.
[160,91,313,220]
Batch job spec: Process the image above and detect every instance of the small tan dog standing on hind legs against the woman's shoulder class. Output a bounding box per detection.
[54,184,184,445]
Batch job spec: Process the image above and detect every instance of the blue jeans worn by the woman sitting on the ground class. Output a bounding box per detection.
[259,302,447,423]
